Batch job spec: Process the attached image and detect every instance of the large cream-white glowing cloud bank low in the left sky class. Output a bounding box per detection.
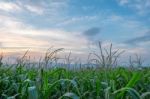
[0,15,87,53]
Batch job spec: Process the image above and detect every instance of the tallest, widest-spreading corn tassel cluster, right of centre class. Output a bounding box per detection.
[89,42,124,68]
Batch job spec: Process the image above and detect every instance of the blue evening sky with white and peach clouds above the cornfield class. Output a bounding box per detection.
[0,0,150,64]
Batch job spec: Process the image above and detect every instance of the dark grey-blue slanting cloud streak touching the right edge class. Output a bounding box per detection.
[126,32,150,44]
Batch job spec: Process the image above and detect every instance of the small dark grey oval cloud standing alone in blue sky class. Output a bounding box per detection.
[83,27,100,37]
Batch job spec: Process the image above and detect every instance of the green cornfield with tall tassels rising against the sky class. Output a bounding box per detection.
[0,43,150,99]
